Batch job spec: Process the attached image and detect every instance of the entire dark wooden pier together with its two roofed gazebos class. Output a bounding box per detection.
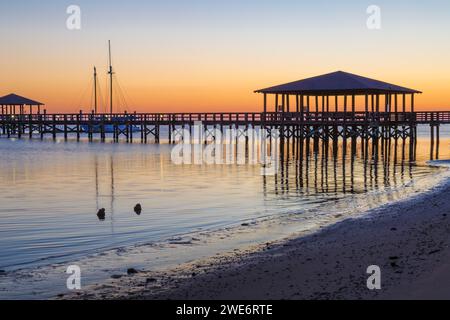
[0,71,450,154]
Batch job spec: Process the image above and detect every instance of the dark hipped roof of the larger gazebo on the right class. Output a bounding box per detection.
[255,71,422,96]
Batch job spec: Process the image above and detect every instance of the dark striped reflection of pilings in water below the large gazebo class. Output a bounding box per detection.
[264,138,417,194]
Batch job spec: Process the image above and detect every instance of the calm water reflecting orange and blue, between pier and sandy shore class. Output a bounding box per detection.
[0,124,450,298]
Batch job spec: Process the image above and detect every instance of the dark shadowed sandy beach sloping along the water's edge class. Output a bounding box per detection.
[59,183,450,299]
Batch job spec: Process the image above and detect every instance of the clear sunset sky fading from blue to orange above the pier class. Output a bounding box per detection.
[0,0,450,112]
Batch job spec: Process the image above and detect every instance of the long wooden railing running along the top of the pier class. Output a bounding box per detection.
[0,111,450,125]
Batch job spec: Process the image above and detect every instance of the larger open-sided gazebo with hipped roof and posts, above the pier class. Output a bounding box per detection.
[255,71,422,115]
